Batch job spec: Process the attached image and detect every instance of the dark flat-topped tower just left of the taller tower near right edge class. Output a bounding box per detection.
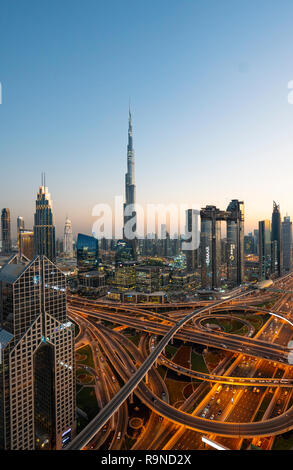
[258,220,272,281]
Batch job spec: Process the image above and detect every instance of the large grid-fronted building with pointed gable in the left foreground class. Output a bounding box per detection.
[0,256,76,450]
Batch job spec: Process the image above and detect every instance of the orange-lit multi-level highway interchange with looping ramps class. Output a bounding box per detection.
[68,276,293,449]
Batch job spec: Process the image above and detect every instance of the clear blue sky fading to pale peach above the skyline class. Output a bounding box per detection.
[0,0,293,235]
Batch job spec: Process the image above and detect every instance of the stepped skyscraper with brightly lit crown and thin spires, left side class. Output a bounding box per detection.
[34,175,56,261]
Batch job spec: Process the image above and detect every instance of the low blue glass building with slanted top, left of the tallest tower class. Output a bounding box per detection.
[76,233,99,272]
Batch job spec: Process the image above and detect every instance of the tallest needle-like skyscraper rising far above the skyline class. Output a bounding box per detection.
[123,109,137,258]
